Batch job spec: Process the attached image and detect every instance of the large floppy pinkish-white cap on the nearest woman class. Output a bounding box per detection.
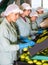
[1,3,23,17]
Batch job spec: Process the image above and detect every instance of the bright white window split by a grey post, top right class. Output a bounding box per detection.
[30,0,48,9]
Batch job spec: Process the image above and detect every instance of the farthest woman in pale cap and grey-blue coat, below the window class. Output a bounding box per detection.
[36,7,48,27]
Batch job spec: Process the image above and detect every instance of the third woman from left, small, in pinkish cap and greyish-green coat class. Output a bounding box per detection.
[30,12,38,30]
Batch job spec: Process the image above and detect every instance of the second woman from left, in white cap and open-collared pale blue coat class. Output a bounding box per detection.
[16,3,31,37]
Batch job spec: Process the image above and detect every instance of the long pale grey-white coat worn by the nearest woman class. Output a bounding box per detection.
[0,18,19,65]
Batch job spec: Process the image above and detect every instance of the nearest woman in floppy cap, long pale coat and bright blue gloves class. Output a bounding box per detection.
[0,4,32,65]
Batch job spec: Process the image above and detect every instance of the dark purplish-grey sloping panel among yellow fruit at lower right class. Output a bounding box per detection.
[28,38,48,56]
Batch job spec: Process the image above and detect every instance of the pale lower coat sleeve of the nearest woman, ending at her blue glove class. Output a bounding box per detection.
[0,35,19,51]
